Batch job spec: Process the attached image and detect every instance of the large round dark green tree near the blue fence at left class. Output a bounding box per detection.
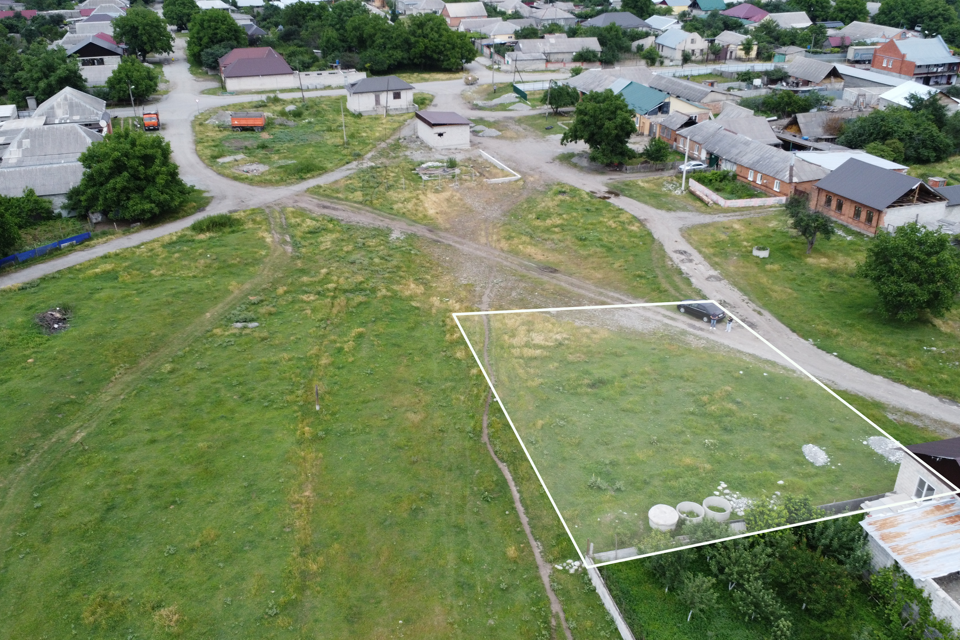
[67,129,189,220]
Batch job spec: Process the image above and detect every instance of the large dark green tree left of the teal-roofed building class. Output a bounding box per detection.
[560,89,637,164]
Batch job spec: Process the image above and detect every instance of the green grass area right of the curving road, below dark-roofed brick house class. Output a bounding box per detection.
[685,215,960,400]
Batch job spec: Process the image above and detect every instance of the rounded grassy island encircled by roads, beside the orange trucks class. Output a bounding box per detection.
[193,98,413,185]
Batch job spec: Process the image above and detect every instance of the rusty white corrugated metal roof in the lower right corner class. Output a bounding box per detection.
[860,499,960,580]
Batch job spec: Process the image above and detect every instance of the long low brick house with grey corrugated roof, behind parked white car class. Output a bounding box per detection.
[676,118,827,197]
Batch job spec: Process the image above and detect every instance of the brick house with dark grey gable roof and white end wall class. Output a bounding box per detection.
[811,158,947,235]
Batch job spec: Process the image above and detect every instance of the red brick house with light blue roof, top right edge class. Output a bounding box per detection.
[870,36,960,86]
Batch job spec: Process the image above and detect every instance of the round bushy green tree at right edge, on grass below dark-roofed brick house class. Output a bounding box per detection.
[857,222,960,322]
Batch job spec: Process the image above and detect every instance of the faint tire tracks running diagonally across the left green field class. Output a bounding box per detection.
[0,214,290,572]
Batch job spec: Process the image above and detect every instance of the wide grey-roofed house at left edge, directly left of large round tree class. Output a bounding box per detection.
[0,124,103,214]
